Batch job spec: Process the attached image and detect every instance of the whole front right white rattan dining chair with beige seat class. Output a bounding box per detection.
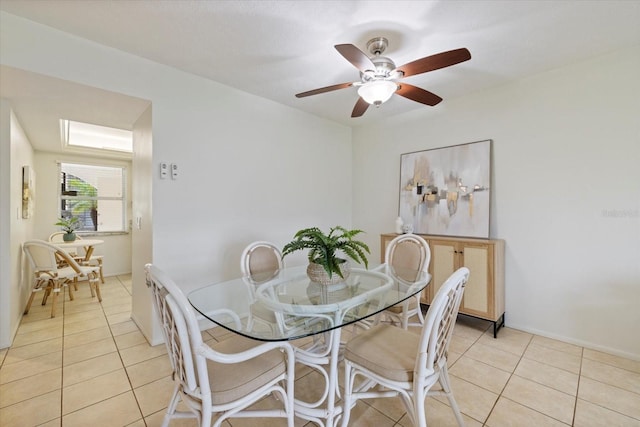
[342,267,469,427]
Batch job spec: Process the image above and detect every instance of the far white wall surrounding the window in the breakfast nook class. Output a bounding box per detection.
[31,151,131,276]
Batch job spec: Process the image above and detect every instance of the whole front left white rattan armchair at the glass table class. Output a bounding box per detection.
[145,264,295,427]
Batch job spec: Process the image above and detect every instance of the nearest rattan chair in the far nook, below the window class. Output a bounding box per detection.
[22,240,102,317]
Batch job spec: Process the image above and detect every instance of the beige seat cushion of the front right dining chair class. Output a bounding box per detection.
[344,324,420,381]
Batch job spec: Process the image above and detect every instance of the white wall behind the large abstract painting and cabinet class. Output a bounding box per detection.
[353,47,640,359]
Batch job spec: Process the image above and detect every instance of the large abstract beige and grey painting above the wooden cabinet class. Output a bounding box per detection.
[399,140,491,238]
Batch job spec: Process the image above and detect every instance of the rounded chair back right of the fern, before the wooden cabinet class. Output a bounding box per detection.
[384,234,431,282]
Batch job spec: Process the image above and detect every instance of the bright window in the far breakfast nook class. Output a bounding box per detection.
[60,163,126,232]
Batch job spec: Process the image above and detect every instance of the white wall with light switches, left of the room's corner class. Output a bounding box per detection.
[0,13,352,344]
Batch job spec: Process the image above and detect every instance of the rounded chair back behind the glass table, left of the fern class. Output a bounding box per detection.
[240,241,284,283]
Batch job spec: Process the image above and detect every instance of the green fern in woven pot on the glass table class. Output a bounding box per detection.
[282,226,370,285]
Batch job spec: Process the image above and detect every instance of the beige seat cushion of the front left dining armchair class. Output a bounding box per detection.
[207,336,286,405]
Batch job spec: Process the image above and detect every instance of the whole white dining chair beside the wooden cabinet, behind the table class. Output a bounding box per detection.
[375,234,431,329]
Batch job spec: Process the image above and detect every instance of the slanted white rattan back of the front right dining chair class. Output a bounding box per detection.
[415,267,469,377]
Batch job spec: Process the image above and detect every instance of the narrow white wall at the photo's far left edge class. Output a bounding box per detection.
[0,99,38,348]
